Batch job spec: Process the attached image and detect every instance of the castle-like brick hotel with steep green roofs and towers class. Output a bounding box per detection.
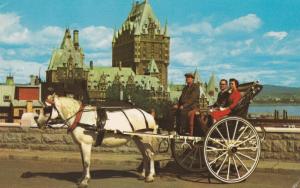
[42,0,216,106]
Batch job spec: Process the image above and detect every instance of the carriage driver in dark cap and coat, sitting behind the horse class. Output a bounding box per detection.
[174,73,200,136]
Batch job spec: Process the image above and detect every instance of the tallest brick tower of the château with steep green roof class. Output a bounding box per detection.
[112,0,170,89]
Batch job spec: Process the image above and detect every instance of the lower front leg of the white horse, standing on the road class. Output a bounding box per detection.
[79,143,92,187]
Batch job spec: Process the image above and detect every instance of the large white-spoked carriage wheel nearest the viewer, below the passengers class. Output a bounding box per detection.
[203,117,261,183]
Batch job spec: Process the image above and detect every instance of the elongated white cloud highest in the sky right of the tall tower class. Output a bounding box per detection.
[215,14,262,34]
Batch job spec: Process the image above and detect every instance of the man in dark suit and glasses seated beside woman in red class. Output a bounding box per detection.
[211,79,230,110]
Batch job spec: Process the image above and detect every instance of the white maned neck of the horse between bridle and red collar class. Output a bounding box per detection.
[58,97,81,118]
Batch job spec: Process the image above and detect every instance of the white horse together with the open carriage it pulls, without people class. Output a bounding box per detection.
[37,82,262,185]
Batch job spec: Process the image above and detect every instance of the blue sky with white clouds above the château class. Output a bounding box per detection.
[0,0,300,87]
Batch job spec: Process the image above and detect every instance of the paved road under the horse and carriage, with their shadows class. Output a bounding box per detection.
[0,159,300,188]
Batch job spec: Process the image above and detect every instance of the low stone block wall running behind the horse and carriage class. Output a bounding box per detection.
[0,127,300,161]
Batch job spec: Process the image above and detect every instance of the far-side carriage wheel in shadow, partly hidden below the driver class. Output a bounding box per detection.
[171,139,206,172]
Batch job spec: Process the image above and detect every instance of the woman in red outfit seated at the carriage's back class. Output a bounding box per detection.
[211,78,241,122]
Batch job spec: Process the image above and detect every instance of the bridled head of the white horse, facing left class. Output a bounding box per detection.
[35,93,59,128]
